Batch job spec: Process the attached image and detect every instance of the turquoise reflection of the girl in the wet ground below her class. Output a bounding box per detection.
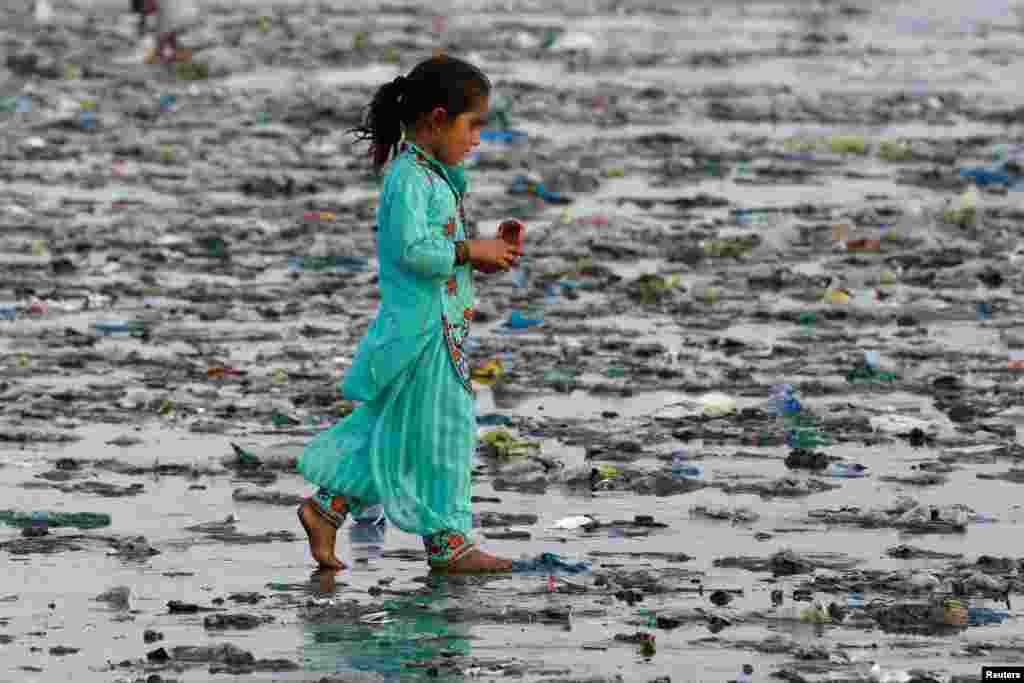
[303,522,473,681]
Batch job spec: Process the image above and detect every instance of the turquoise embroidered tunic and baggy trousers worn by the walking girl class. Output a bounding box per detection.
[298,144,476,561]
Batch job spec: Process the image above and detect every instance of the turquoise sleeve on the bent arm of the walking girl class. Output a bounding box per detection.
[390,166,455,279]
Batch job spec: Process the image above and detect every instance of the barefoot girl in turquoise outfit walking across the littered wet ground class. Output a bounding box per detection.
[298,54,519,572]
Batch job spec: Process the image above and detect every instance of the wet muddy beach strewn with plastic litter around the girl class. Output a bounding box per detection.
[0,0,1024,683]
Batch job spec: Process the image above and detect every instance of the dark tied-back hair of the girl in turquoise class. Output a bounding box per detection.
[347,54,490,172]
